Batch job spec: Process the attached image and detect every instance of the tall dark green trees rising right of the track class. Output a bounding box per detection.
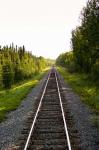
[57,0,99,78]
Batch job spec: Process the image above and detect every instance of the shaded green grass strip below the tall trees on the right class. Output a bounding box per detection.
[58,67,99,115]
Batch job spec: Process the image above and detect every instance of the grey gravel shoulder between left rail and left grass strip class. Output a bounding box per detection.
[0,75,47,150]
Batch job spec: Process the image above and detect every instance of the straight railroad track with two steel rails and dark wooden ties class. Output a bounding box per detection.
[16,68,81,150]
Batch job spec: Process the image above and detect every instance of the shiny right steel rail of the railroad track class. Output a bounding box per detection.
[55,72,71,150]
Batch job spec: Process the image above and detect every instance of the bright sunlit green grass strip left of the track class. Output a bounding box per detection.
[0,69,48,122]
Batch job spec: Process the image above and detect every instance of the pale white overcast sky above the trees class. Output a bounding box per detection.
[0,0,87,59]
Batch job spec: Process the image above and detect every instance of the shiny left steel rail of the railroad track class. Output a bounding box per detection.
[24,72,51,150]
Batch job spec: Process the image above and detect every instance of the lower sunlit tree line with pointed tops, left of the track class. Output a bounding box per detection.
[0,43,47,88]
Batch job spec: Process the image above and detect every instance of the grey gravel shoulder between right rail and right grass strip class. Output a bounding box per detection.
[58,73,99,150]
